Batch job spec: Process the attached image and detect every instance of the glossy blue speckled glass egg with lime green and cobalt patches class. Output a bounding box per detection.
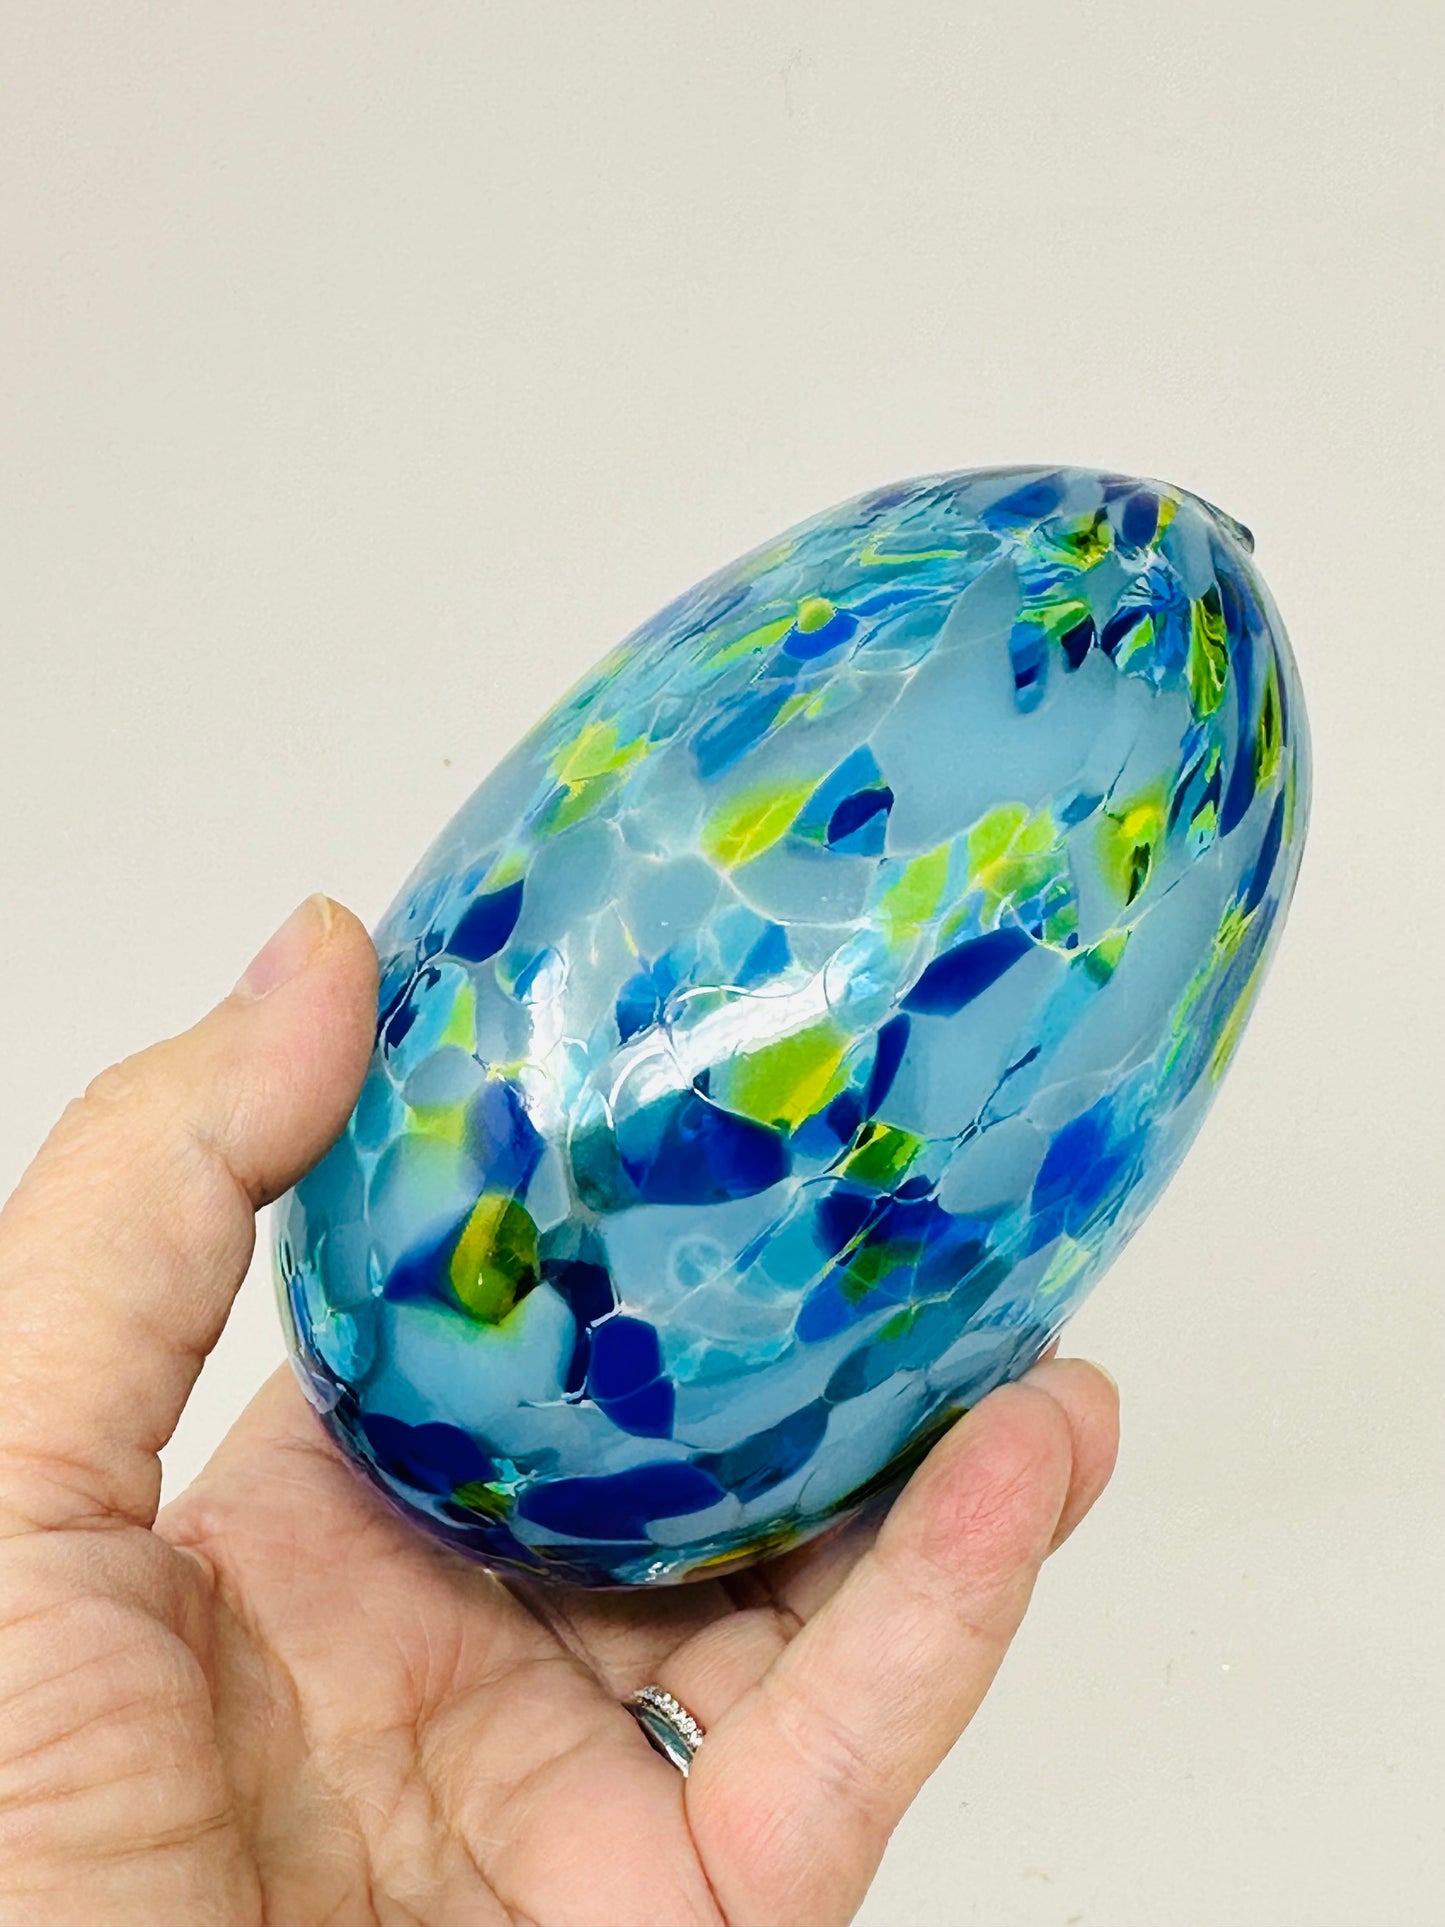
[277,470,1308,1586]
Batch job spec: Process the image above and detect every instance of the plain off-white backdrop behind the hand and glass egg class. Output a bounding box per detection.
[0,0,1445,1927]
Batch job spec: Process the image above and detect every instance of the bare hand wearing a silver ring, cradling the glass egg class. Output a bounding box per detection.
[0,898,1116,1927]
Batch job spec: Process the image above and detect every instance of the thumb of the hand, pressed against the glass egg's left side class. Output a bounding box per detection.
[0,896,376,1530]
